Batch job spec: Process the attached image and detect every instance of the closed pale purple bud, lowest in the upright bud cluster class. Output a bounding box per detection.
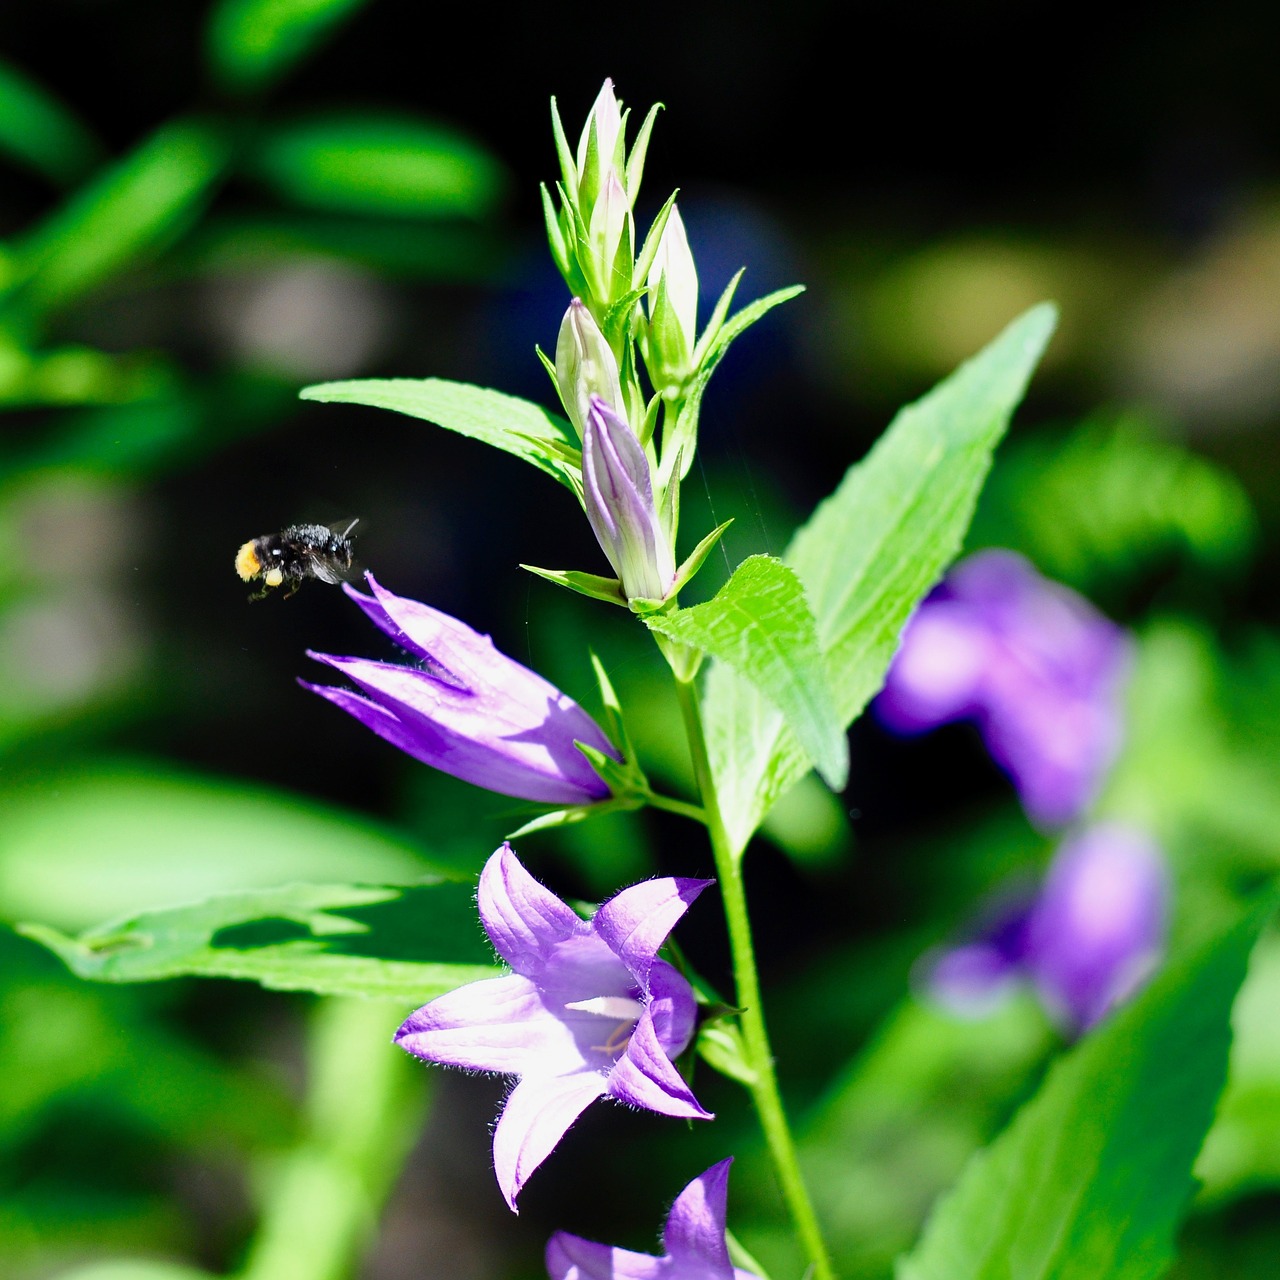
[582,396,676,600]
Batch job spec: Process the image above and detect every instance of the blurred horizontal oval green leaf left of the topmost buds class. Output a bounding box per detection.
[250,114,506,218]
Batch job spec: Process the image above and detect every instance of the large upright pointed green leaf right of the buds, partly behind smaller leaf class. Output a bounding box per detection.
[705,303,1056,852]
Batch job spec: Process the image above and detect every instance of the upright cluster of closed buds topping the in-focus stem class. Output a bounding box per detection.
[538,81,790,612]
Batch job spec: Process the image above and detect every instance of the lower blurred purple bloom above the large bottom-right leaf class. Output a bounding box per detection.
[927,822,1169,1033]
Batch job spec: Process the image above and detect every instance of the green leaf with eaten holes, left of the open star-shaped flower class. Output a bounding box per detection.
[18,877,498,1005]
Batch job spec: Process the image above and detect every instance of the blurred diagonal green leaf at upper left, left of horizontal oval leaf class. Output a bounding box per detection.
[15,120,229,311]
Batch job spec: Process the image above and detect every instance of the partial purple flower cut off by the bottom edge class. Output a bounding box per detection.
[547,1160,756,1280]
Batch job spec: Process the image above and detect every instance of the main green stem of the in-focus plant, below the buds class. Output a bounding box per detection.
[676,678,836,1280]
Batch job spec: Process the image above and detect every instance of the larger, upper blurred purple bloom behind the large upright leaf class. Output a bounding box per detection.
[876,550,1129,827]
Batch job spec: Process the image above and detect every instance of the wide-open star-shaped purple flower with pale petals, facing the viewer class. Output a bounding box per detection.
[396,845,712,1211]
